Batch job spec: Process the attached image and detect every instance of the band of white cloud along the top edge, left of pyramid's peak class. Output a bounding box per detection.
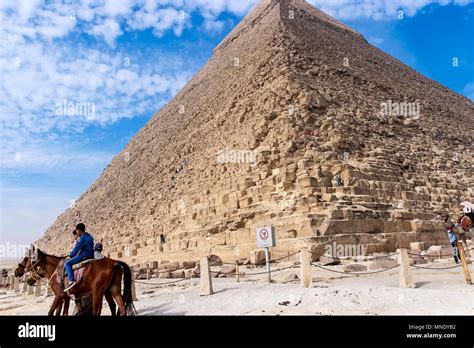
[0,0,258,48]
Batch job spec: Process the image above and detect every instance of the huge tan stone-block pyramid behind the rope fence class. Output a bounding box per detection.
[39,0,474,264]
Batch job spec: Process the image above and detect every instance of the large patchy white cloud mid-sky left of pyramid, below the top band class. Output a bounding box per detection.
[0,35,192,171]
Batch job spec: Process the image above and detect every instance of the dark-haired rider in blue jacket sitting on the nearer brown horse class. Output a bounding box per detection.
[64,223,94,291]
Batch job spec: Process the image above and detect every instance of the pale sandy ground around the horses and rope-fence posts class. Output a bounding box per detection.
[0,260,474,315]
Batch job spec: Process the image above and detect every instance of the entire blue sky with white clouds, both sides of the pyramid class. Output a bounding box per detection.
[0,0,474,243]
